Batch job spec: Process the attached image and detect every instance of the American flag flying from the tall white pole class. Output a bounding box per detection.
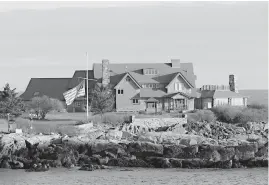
[63,80,85,105]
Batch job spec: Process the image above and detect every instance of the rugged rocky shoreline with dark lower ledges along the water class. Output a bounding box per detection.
[0,133,268,171]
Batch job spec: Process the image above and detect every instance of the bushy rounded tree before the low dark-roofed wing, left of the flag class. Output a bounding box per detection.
[29,96,64,119]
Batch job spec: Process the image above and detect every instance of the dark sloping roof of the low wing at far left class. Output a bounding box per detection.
[20,78,71,100]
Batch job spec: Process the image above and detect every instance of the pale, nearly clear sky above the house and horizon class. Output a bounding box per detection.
[0,2,268,91]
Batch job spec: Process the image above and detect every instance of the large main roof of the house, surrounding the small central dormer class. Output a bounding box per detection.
[93,63,196,87]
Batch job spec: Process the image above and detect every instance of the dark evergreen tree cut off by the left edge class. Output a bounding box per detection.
[0,83,25,117]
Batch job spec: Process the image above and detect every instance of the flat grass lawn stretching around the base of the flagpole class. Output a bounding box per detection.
[15,112,182,136]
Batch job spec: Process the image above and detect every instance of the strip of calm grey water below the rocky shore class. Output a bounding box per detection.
[0,168,268,185]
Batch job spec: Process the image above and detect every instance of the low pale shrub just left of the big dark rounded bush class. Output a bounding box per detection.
[187,110,216,122]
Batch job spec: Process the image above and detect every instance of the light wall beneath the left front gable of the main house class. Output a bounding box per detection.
[115,76,145,111]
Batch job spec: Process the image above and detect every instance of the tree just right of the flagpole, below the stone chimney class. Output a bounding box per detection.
[90,84,115,115]
